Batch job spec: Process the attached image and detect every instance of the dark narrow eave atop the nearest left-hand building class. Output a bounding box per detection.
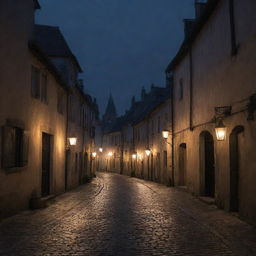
[28,41,68,89]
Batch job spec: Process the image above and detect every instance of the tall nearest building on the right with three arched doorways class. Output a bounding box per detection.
[166,0,256,223]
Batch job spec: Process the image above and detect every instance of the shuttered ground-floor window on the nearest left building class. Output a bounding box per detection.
[2,126,28,169]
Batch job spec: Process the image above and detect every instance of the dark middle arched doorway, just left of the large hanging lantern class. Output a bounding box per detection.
[200,131,215,197]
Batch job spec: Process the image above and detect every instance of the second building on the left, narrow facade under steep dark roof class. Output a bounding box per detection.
[34,25,97,189]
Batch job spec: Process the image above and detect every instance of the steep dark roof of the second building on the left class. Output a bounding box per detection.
[33,24,83,72]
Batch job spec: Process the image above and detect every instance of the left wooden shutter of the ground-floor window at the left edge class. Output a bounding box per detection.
[2,126,16,168]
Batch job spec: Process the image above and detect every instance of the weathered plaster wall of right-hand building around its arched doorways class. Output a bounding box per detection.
[173,0,256,223]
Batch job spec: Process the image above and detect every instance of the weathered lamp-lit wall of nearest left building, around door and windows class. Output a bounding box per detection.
[0,1,66,217]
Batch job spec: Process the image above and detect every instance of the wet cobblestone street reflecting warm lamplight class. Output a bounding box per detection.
[0,173,256,256]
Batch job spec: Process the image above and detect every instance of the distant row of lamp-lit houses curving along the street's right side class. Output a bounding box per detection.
[102,85,170,183]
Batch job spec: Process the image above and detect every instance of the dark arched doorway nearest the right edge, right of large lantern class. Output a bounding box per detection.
[229,126,244,212]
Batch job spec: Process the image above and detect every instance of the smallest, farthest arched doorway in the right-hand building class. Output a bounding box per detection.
[179,143,187,186]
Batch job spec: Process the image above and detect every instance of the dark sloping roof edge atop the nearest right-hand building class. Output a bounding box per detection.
[165,0,220,72]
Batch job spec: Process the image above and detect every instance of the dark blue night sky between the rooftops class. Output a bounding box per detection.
[36,0,194,114]
